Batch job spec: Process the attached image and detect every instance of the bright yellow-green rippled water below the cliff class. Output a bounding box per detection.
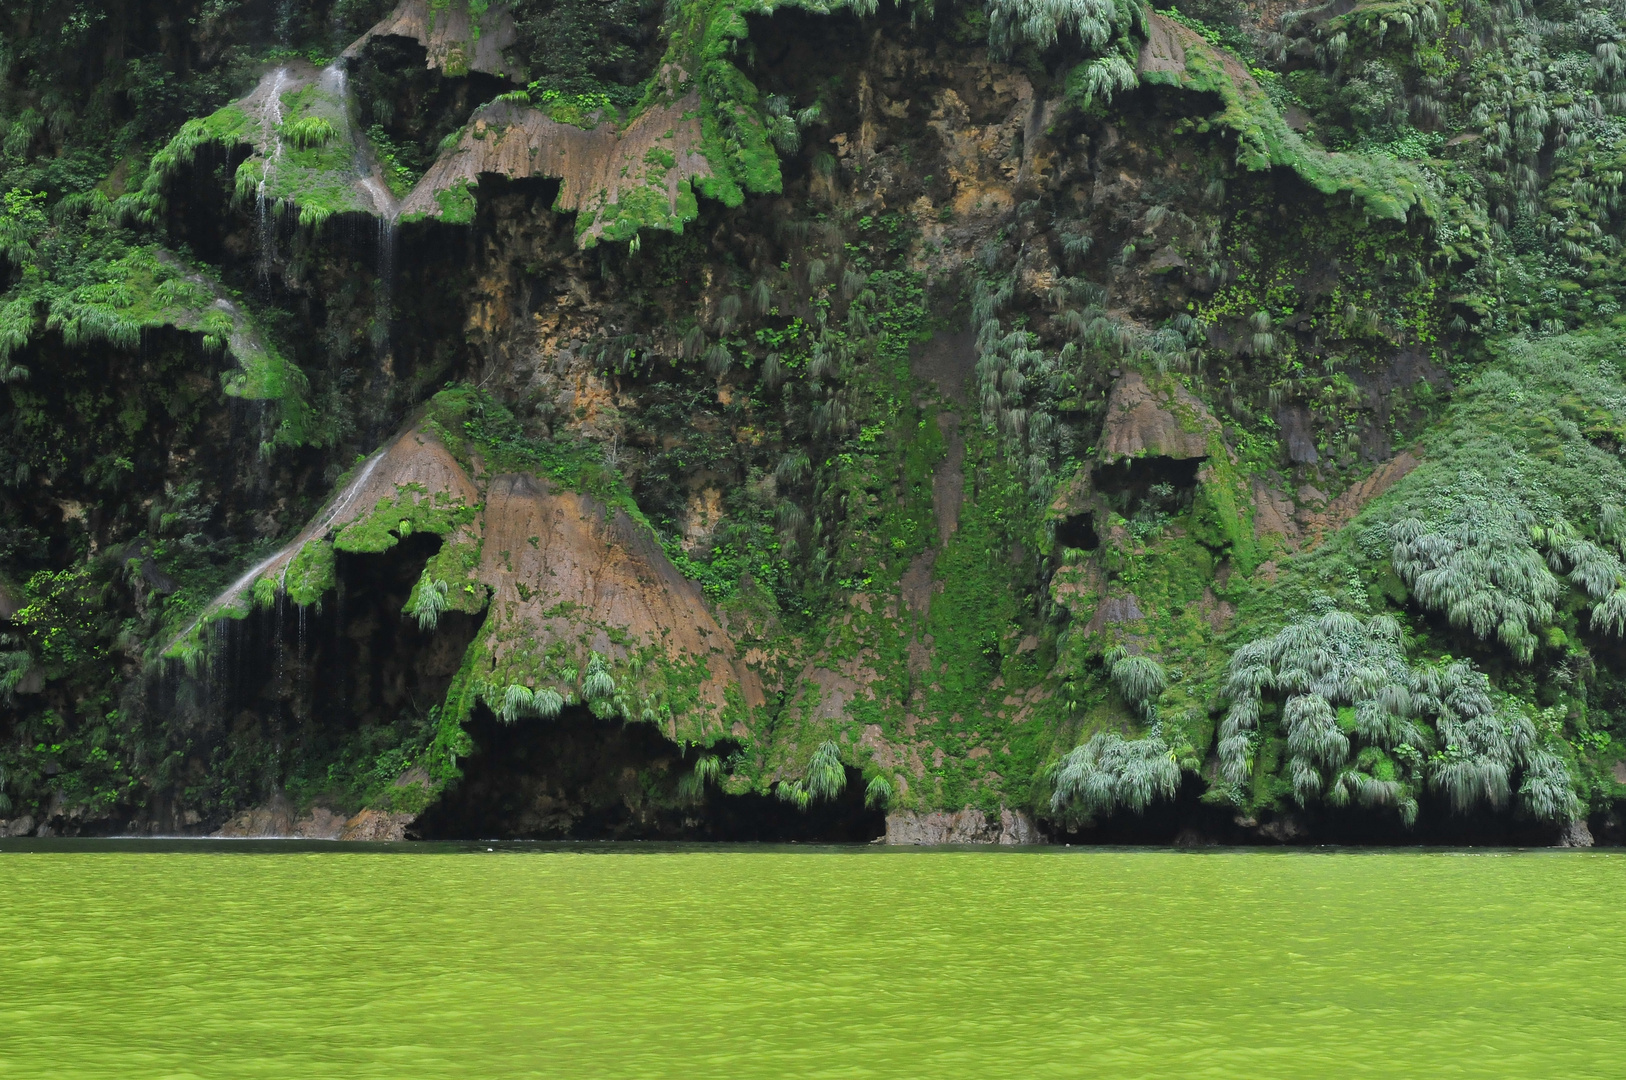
[0,846,1626,1080]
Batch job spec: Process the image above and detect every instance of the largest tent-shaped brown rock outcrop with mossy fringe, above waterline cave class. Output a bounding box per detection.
[181,425,764,742]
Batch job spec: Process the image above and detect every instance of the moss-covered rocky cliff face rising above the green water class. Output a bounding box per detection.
[9,0,1626,843]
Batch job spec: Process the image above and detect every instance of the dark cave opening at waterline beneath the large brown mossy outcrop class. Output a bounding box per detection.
[408,706,886,843]
